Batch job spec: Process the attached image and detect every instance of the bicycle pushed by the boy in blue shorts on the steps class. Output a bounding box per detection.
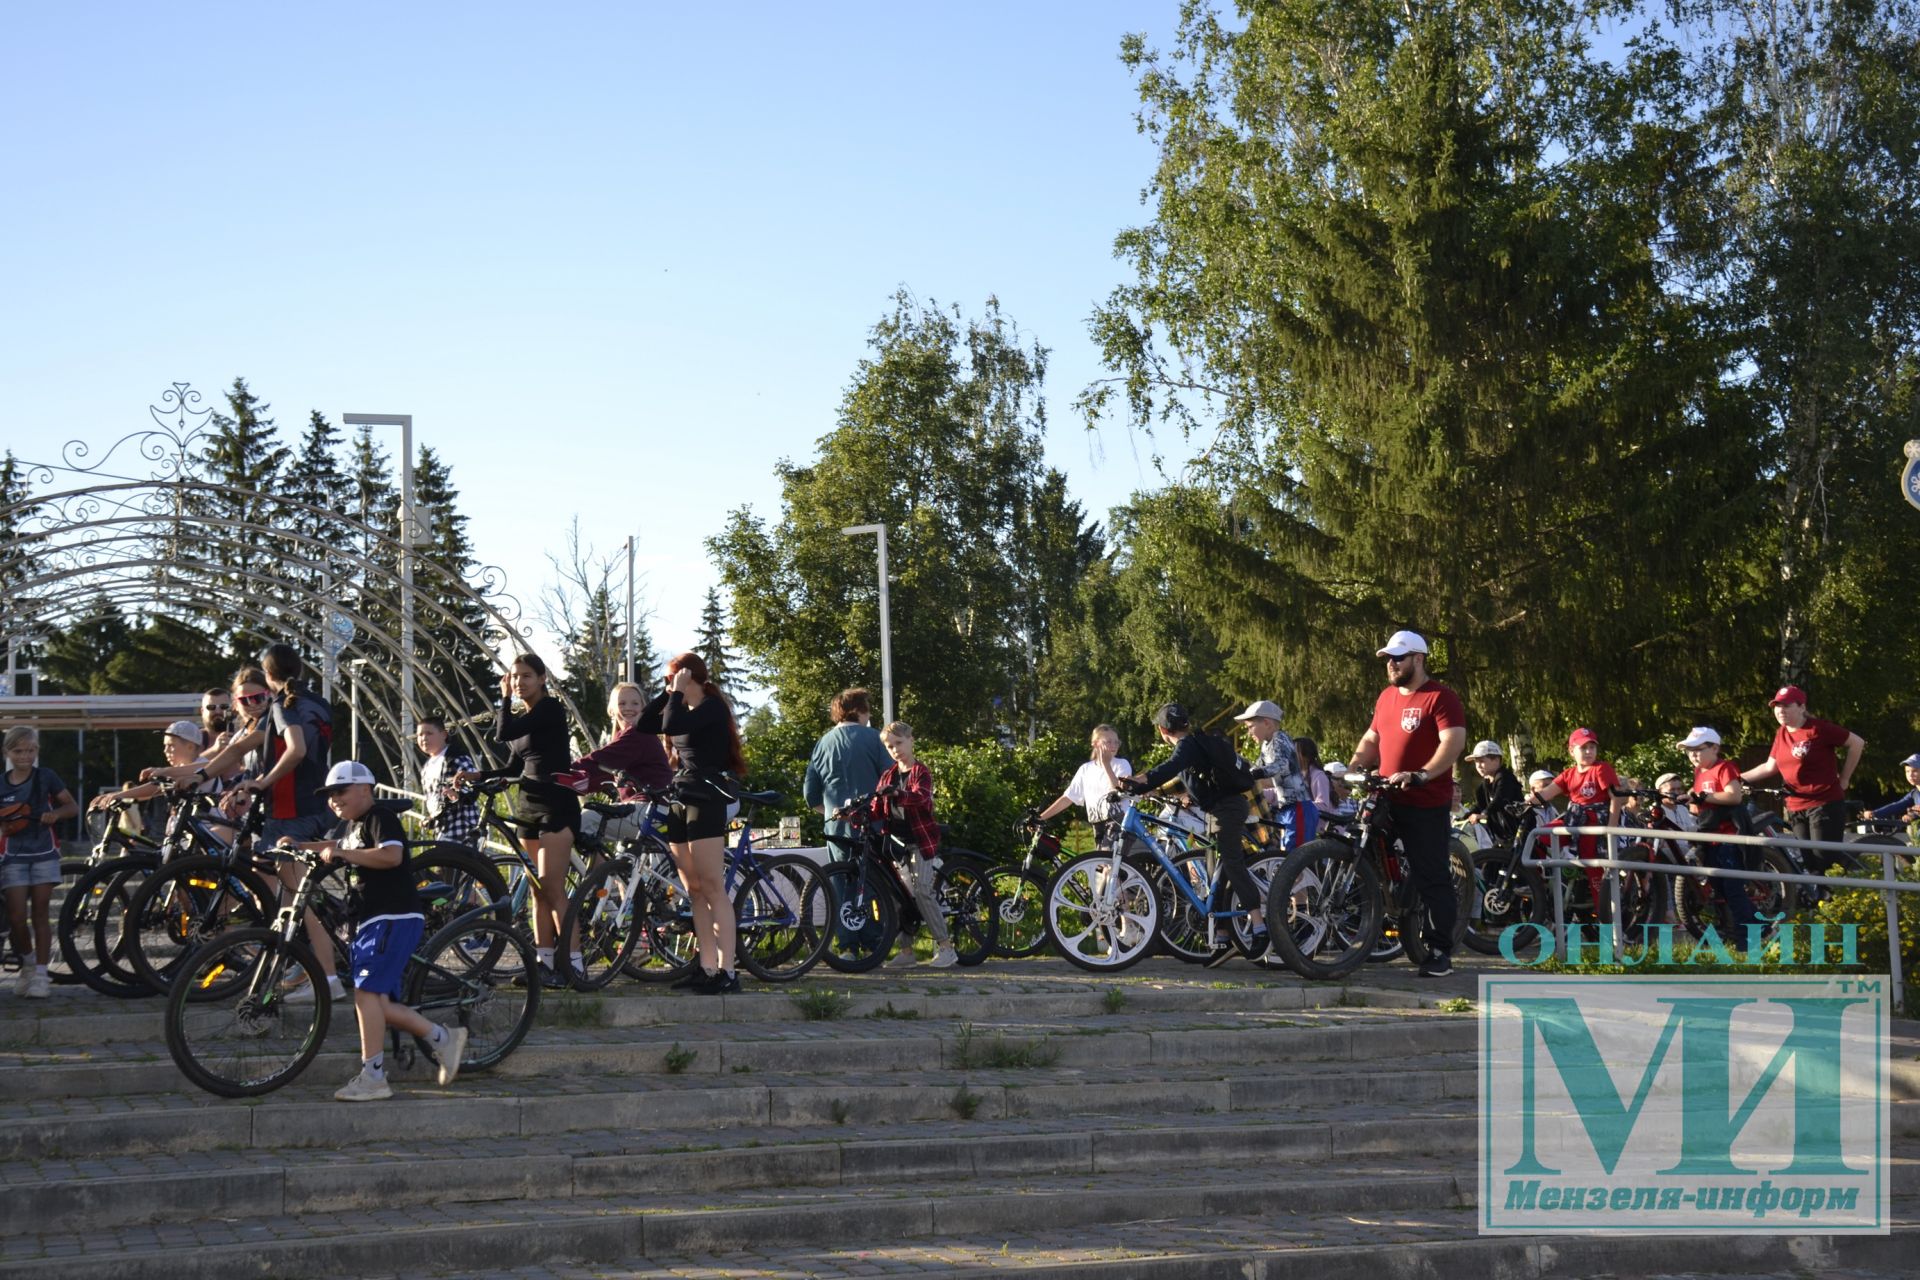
[165,850,540,1098]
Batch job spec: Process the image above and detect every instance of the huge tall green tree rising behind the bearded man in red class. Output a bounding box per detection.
[1083,0,1755,744]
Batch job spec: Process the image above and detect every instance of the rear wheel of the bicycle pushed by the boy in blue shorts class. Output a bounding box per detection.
[405,915,540,1073]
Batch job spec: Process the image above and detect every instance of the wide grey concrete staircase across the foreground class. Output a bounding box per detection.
[0,961,1920,1280]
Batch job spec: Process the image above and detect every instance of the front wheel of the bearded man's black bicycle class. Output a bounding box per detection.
[1267,839,1386,981]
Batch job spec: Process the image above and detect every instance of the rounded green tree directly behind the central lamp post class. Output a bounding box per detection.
[708,292,1046,741]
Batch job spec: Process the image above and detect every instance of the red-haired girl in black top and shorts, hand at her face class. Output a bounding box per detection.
[660,652,747,994]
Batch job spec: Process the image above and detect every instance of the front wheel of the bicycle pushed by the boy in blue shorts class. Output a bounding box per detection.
[165,929,334,1098]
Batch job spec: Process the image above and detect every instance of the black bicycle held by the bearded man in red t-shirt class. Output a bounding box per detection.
[1267,771,1473,981]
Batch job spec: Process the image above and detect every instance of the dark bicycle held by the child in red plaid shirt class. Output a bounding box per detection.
[818,791,1000,973]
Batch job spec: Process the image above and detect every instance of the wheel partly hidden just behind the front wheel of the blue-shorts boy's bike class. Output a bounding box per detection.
[121,858,276,998]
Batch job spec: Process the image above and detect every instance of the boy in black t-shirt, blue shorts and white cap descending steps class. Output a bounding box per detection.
[289,760,467,1102]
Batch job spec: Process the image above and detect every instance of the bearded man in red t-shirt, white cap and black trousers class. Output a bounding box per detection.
[1346,631,1467,977]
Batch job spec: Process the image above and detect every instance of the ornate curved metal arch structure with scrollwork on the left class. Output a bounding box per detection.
[0,382,580,781]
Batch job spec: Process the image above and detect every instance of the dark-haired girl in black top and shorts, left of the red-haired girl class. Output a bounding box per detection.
[455,652,586,986]
